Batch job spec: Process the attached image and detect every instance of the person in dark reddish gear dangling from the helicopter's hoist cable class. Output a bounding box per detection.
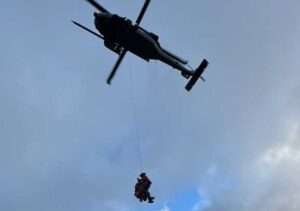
[135,172,154,203]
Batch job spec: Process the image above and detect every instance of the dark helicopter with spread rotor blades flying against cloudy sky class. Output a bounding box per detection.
[72,0,209,91]
